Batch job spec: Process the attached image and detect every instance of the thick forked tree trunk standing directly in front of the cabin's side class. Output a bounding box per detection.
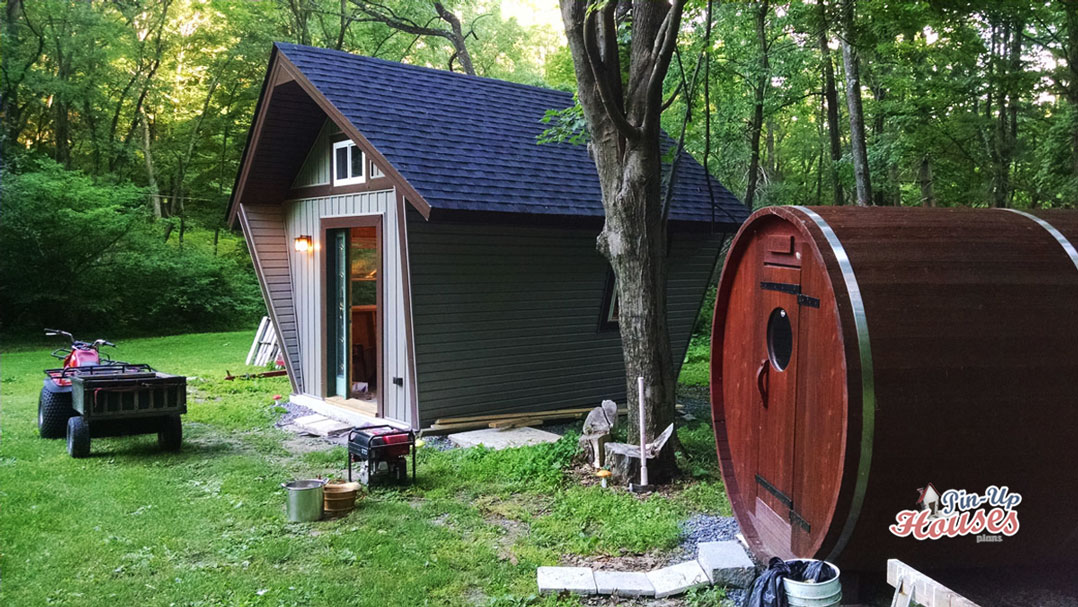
[562,0,685,477]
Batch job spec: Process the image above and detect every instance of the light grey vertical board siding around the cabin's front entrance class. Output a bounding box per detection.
[285,190,414,425]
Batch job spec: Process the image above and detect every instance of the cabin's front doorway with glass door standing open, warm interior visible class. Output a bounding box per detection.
[323,217,384,415]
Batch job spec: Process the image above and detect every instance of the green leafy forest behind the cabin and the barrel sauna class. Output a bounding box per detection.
[0,0,1078,337]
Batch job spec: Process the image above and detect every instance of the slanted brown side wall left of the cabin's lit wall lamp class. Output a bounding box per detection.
[239,205,304,390]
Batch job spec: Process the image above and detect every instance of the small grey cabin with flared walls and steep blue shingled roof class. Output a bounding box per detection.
[229,43,747,428]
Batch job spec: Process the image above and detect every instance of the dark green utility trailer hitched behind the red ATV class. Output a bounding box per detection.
[42,362,188,457]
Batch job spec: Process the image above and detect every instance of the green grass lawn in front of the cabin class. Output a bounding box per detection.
[0,332,729,607]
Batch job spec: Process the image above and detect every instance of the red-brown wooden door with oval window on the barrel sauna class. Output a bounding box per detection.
[754,233,801,546]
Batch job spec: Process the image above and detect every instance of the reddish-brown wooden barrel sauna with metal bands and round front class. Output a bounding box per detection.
[711,206,1078,570]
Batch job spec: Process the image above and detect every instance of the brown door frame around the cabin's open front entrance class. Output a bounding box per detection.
[318,213,386,417]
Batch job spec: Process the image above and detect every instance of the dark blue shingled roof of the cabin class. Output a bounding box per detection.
[276,43,748,224]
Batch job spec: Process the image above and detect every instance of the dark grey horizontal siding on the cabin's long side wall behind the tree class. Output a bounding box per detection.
[407,218,721,426]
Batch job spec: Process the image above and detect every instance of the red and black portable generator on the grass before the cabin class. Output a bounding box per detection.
[347,425,415,486]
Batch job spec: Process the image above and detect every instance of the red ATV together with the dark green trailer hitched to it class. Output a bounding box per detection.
[38,329,186,457]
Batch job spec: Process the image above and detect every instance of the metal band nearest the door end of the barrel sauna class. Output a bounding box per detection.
[791,206,875,561]
